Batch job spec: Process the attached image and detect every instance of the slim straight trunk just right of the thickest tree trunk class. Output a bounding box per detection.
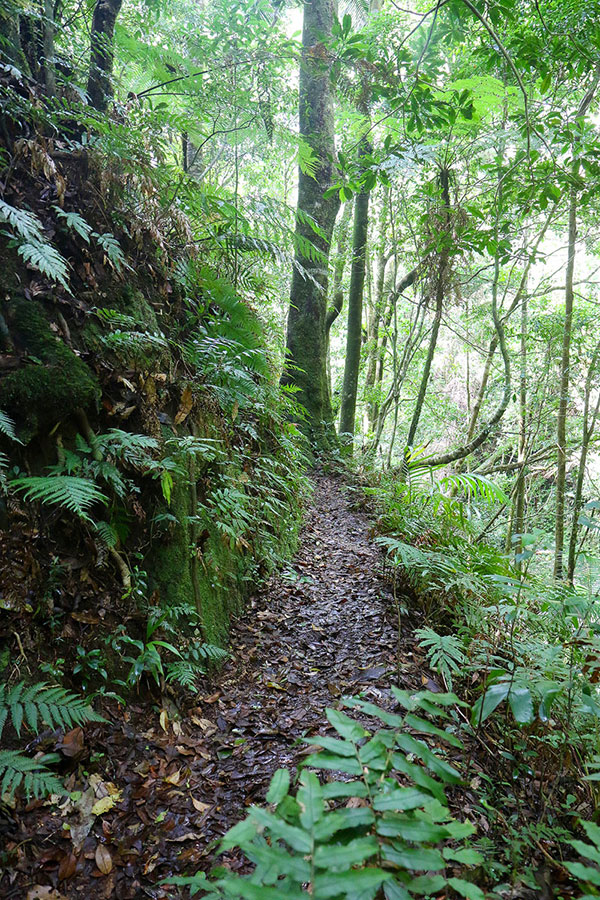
[340,139,371,444]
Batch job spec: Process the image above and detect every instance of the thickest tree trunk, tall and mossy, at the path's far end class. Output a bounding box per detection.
[282,0,339,446]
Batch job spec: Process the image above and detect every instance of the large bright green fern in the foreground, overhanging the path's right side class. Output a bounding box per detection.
[169,689,484,900]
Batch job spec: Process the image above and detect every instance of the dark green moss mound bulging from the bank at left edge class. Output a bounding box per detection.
[0,300,101,441]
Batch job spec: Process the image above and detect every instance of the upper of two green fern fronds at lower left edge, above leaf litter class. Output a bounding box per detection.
[0,681,104,737]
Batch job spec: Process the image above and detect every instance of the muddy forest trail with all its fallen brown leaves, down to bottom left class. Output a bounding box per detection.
[0,476,416,900]
